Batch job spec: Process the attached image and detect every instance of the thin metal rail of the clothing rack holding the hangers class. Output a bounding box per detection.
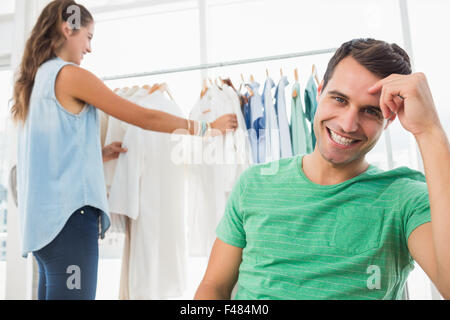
[101,48,337,81]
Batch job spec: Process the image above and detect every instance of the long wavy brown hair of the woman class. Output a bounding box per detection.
[11,0,94,122]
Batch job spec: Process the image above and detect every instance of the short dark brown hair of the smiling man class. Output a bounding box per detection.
[323,38,411,89]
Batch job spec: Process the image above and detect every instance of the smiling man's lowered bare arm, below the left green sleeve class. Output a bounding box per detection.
[194,238,242,300]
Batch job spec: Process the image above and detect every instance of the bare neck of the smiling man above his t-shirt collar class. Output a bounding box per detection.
[302,148,369,185]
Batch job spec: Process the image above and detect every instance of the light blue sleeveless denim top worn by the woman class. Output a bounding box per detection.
[17,57,110,257]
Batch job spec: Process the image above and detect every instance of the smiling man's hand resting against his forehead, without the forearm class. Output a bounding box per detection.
[369,72,441,137]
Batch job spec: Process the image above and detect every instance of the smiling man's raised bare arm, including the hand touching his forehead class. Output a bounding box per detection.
[369,73,450,299]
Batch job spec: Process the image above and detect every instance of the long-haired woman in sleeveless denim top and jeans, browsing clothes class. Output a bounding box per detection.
[12,0,237,299]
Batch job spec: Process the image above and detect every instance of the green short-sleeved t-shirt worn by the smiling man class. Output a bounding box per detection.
[216,155,431,299]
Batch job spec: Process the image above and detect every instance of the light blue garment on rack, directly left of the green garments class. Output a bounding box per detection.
[275,76,292,158]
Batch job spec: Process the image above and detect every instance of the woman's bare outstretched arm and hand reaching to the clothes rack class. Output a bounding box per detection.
[57,65,237,135]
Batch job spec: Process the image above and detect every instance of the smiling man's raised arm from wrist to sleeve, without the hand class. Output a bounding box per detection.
[408,127,450,299]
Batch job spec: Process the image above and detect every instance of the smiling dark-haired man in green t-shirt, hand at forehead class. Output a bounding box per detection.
[195,39,450,299]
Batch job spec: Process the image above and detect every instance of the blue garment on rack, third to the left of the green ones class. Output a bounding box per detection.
[248,82,266,163]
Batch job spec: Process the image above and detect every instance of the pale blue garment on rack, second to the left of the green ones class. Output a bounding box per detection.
[262,77,280,162]
